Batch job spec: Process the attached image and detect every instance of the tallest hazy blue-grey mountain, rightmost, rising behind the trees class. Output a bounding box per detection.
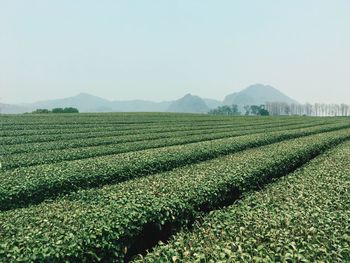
[223,84,298,106]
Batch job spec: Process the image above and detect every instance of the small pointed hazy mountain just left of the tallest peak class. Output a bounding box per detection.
[167,94,209,113]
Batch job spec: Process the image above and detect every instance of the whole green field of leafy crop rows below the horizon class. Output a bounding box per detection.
[0,113,350,262]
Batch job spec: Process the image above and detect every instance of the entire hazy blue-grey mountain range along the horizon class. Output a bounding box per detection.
[0,84,298,113]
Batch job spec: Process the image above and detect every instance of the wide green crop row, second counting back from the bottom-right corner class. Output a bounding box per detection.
[0,130,350,262]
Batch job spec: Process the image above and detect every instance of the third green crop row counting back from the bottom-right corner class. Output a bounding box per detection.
[0,125,349,210]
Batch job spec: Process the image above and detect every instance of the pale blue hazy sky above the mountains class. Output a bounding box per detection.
[0,0,350,104]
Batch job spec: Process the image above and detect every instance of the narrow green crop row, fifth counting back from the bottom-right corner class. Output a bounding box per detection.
[0,118,304,155]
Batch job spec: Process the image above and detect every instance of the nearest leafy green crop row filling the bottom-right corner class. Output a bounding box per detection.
[141,143,350,262]
